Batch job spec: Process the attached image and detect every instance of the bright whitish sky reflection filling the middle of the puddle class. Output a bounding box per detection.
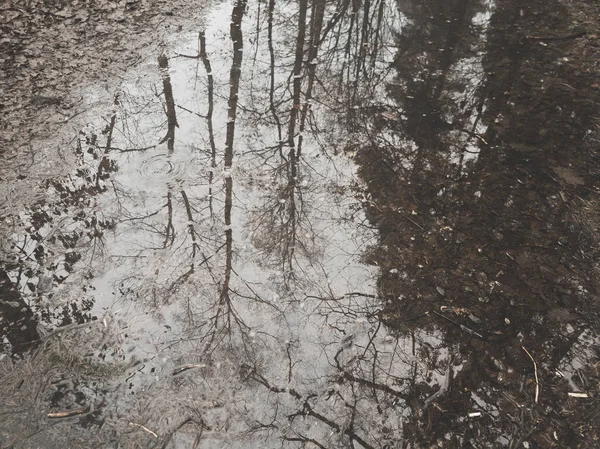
[78,0,436,444]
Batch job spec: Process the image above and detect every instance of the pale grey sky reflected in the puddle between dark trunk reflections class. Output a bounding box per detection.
[3,3,482,444]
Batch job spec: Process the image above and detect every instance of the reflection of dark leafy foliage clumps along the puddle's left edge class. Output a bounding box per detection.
[0,111,120,354]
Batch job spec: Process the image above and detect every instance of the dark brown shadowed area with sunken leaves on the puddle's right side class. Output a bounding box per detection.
[358,0,600,448]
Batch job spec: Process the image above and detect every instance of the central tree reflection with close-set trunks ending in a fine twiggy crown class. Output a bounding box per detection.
[244,1,325,287]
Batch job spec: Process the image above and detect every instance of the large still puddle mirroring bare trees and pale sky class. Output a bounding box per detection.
[0,0,600,448]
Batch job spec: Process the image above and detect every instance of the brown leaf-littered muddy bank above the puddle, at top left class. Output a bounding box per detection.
[0,0,204,222]
